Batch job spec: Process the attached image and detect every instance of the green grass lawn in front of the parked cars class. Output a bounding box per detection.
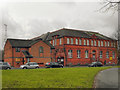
[2,67,110,88]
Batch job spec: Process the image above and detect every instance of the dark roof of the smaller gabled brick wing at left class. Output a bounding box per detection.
[7,39,54,48]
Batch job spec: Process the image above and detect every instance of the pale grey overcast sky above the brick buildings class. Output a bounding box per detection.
[0,0,118,49]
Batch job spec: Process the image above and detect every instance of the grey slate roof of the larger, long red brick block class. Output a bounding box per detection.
[37,28,115,41]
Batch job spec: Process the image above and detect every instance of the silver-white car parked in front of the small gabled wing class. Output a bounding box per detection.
[20,62,39,69]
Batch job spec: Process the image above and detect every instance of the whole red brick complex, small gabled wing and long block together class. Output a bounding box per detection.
[4,28,117,67]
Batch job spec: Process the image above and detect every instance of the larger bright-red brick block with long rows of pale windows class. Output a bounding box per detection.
[38,28,117,66]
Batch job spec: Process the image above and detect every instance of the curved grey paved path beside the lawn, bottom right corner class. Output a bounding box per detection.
[95,68,120,89]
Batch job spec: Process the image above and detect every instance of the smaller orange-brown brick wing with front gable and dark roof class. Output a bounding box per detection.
[4,39,54,67]
